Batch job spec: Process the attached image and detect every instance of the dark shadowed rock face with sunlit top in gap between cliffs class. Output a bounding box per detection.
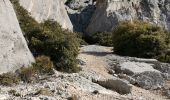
[65,0,95,33]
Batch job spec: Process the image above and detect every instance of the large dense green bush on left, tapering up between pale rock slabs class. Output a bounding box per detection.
[11,0,81,72]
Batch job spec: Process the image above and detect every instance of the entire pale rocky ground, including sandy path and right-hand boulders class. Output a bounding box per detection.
[0,45,170,100]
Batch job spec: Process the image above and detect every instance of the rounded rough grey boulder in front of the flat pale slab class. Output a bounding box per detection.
[133,71,165,89]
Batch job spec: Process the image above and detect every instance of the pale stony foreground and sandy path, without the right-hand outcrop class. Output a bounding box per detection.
[0,45,170,100]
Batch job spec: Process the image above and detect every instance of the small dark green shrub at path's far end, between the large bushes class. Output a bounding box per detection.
[92,32,113,46]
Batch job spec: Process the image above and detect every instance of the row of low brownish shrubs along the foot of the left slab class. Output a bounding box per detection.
[0,56,54,86]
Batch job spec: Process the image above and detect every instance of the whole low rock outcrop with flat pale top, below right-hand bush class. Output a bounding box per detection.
[108,55,165,89]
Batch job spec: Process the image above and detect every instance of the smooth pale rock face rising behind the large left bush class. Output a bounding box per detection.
[20,0,73,30]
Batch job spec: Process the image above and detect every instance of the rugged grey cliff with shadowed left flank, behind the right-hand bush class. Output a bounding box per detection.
[86,0,170,34]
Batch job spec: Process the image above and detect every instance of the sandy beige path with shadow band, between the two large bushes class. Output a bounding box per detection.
[79,47,113,79]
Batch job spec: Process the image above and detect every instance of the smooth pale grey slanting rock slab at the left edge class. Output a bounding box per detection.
[0,0,34,74]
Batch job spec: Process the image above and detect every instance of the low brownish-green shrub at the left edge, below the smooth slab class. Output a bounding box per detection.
[0,73,20,86]
